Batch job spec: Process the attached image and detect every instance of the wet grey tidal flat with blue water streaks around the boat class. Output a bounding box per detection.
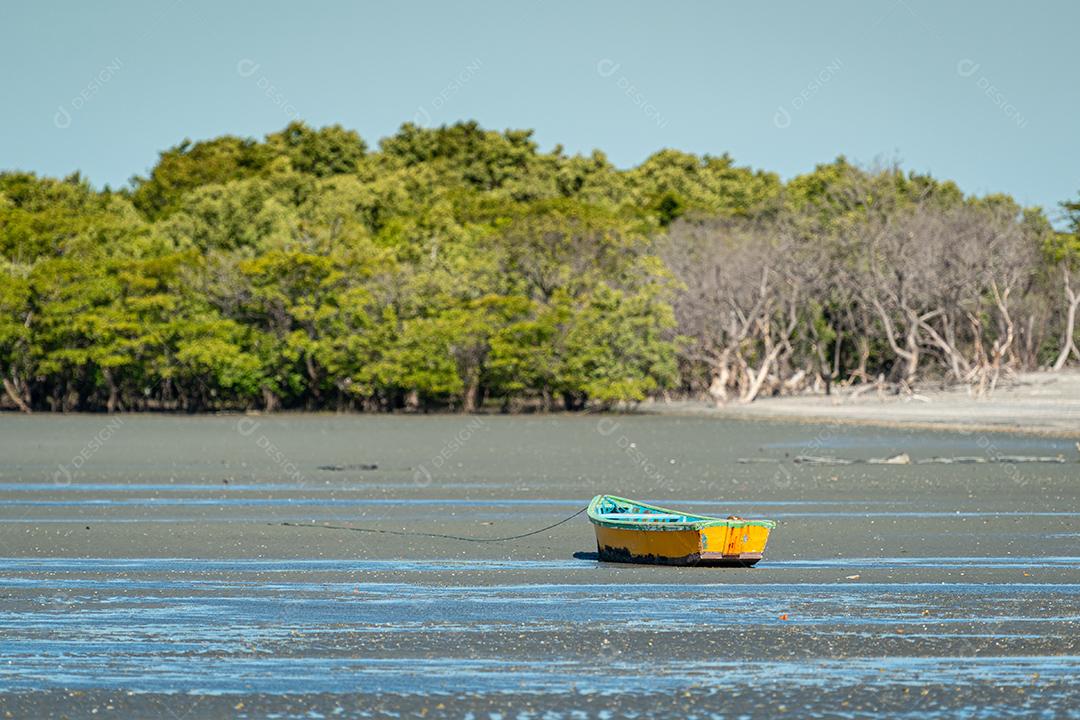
[0,416,1080,718]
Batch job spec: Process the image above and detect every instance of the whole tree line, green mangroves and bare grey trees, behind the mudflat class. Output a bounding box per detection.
[0,122,1080,412]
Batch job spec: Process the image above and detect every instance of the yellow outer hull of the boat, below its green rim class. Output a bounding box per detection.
[593,525,769,568]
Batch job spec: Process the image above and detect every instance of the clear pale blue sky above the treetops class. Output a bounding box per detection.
[0,0,1080,221]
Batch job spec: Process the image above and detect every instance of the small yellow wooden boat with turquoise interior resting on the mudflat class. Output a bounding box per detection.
[589,495,777,567]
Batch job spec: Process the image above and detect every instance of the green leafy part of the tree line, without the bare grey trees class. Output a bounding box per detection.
[0,122,1062,410]
